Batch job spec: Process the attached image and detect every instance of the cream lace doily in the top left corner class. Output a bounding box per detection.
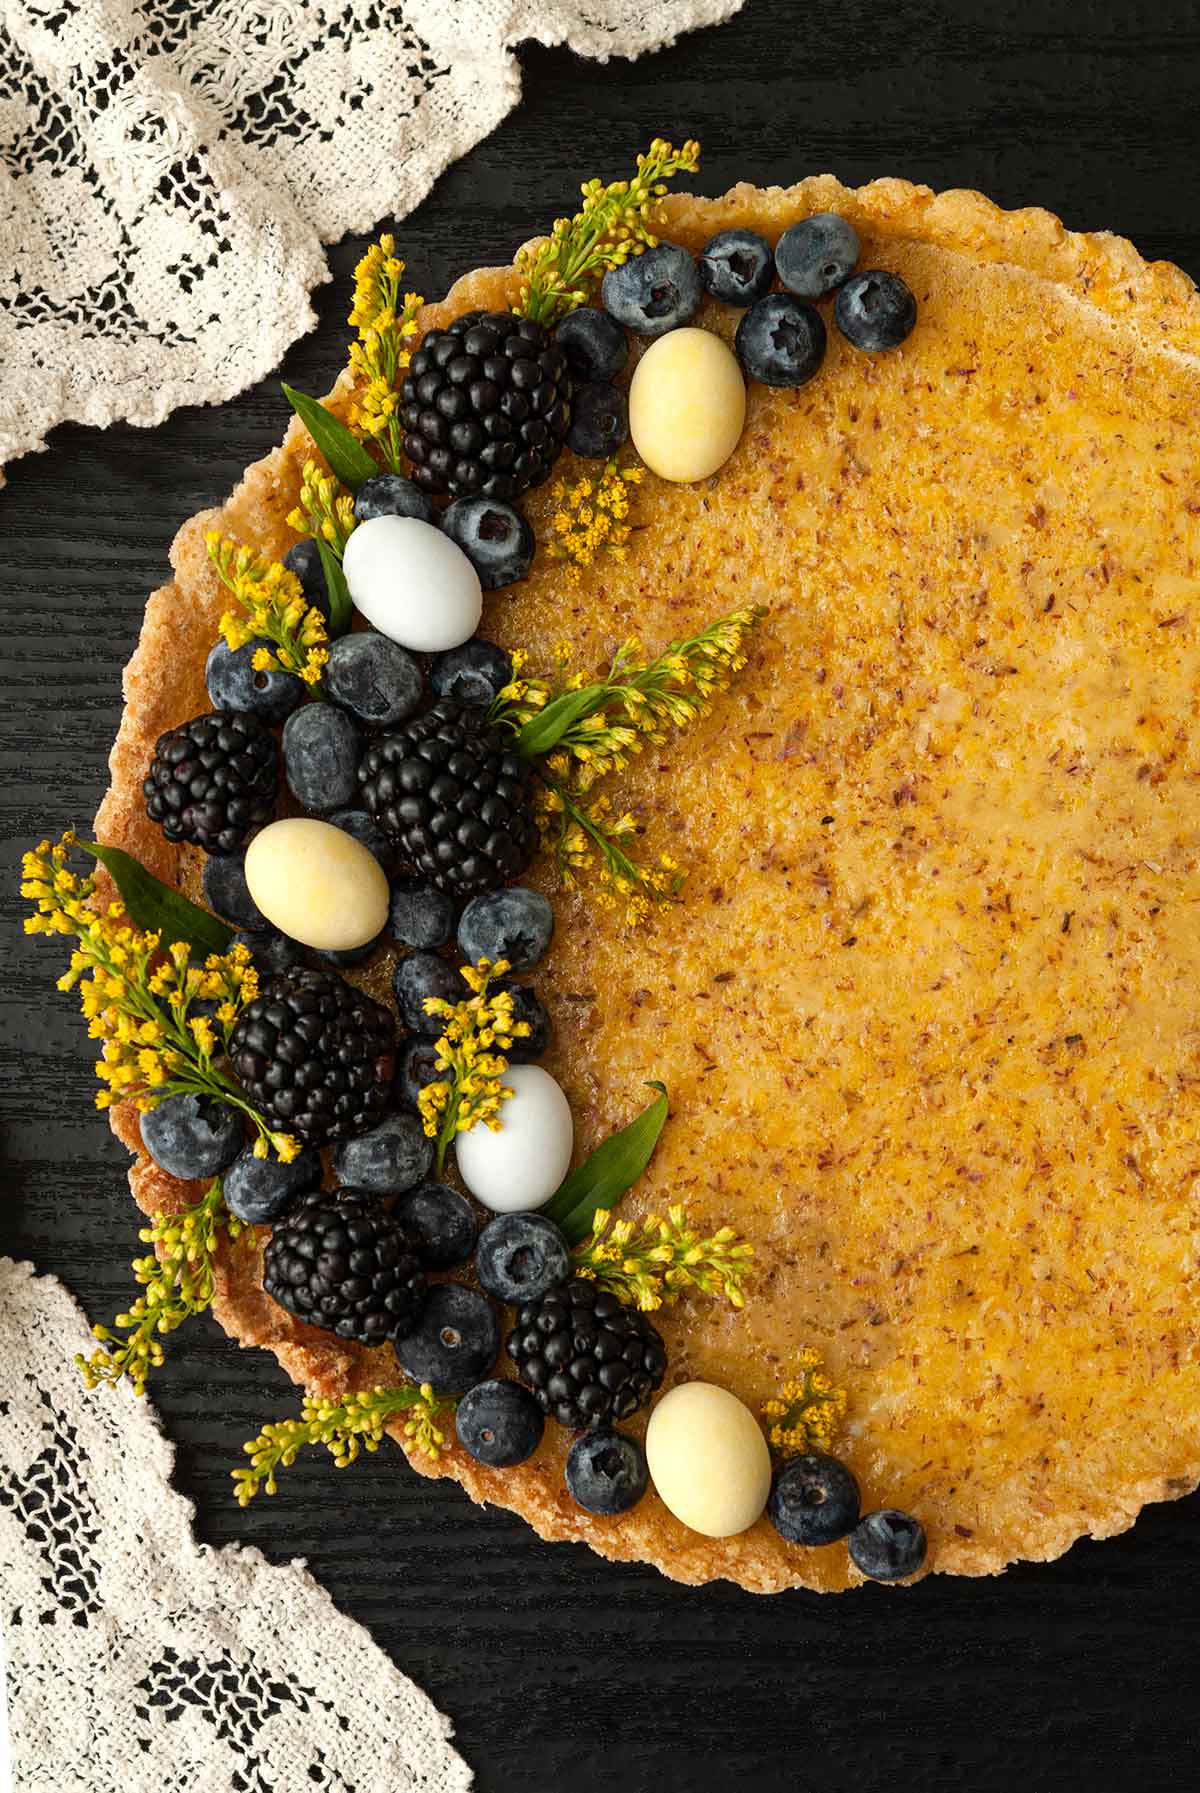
[0,0,741,484]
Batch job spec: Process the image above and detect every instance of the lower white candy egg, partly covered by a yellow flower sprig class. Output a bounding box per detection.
[454,1065,574,1214]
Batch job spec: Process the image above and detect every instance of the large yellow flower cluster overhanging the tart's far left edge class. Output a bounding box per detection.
[22,834,300,1164]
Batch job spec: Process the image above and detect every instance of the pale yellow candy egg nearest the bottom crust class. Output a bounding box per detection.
[646,1377,771,1538]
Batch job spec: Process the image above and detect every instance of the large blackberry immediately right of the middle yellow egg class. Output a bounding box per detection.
[359,699,538,897]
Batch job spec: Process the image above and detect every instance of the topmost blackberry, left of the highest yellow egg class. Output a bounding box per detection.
[400,312,570,498]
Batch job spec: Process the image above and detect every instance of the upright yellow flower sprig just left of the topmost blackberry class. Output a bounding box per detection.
[350,237,425,473]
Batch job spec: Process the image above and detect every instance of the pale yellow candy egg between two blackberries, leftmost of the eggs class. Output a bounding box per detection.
[246,816,387,952]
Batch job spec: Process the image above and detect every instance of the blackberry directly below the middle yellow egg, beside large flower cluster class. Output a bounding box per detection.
[230,966,396,1146]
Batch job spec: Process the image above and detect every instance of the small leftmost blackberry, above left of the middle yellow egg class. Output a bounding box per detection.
[142,710,280,853]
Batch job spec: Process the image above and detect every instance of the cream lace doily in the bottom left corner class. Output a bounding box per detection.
[0,1259,472,1793]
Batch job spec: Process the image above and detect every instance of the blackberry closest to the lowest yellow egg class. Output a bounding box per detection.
[508,1277,667,1431]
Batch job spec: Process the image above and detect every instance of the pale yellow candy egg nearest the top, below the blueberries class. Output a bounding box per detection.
[627,326,746,484]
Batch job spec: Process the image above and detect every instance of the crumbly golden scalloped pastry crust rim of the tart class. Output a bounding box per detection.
[95,174,1200,1594]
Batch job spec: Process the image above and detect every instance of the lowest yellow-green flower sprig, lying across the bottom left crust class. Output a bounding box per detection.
[233,1382,457,1506]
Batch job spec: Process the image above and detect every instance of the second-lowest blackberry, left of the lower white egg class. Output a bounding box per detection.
[262,1189,425,1345]
